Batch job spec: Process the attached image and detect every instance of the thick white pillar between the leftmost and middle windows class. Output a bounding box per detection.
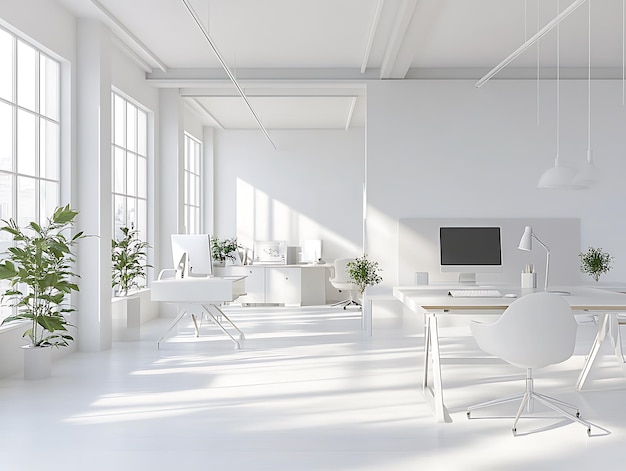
[75,19,112,351]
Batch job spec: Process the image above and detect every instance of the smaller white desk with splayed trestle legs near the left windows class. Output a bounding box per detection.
[150,277,246,349]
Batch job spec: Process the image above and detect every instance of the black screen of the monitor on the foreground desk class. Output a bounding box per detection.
[439,227,502,266]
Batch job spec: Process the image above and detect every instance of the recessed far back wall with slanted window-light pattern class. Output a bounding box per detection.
[214,128,365,260]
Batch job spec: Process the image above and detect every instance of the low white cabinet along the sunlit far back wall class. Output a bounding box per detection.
[216,265,329,306]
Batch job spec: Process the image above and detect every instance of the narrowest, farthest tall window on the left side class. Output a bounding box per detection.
[183,133,202,234]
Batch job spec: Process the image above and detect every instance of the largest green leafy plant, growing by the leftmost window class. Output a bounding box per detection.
[0,205,84,347]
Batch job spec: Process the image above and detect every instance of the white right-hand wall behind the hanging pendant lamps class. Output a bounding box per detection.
[367,80,626,285]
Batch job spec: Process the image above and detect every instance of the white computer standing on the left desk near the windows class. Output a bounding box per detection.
[171,234,213,278]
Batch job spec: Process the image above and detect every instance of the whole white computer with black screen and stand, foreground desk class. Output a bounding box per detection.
[439,227,502,285]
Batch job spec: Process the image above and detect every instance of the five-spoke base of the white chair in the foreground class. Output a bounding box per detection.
[467,368,591,435]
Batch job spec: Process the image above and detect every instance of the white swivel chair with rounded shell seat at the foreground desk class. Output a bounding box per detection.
[467,293,591,435]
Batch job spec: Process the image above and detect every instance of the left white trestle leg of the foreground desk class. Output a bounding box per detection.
[422,313,452,422]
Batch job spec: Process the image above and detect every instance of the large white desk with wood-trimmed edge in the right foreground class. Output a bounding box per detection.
[393,286,626,422]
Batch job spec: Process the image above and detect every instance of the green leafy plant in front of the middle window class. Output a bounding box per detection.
[111,227,152,296]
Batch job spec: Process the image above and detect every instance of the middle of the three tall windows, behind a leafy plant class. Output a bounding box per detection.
[111,92,148,241]
